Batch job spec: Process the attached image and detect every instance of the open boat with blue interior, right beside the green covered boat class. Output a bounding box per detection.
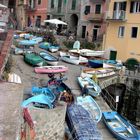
[39,51,58,66]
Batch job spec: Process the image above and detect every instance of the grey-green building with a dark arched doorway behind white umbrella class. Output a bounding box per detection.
[47,0,81,33]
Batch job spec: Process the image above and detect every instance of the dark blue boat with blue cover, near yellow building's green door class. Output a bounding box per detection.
[88,60,117,68]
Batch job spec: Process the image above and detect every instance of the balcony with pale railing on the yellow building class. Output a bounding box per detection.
[106,10,127,21]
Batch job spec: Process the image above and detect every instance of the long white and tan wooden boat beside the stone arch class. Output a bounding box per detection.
[81,68,115,78]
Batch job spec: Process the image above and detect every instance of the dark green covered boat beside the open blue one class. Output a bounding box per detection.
[24,52,46,66]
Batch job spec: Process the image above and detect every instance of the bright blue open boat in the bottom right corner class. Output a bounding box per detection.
[103,111,140,140]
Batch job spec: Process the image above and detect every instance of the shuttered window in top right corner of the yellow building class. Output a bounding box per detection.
[130,1,140,13]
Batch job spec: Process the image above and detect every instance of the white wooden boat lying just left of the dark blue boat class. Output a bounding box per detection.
[61,54,88,65]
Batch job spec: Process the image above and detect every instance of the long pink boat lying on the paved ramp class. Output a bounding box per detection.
[35,65,68,74]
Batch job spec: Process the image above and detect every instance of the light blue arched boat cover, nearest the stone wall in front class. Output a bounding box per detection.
[21,94,53,108]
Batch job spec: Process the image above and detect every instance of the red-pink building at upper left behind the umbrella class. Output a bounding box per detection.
[16,0,48,30]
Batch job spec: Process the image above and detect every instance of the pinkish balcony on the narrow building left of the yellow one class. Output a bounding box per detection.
[86,13,104,22]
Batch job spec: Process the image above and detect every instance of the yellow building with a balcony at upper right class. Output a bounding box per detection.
[103,0,140,61]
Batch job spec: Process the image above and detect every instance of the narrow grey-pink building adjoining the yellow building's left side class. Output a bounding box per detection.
[78,0,108,43]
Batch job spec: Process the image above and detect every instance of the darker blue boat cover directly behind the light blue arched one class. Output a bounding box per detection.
[32,86,56,103]
